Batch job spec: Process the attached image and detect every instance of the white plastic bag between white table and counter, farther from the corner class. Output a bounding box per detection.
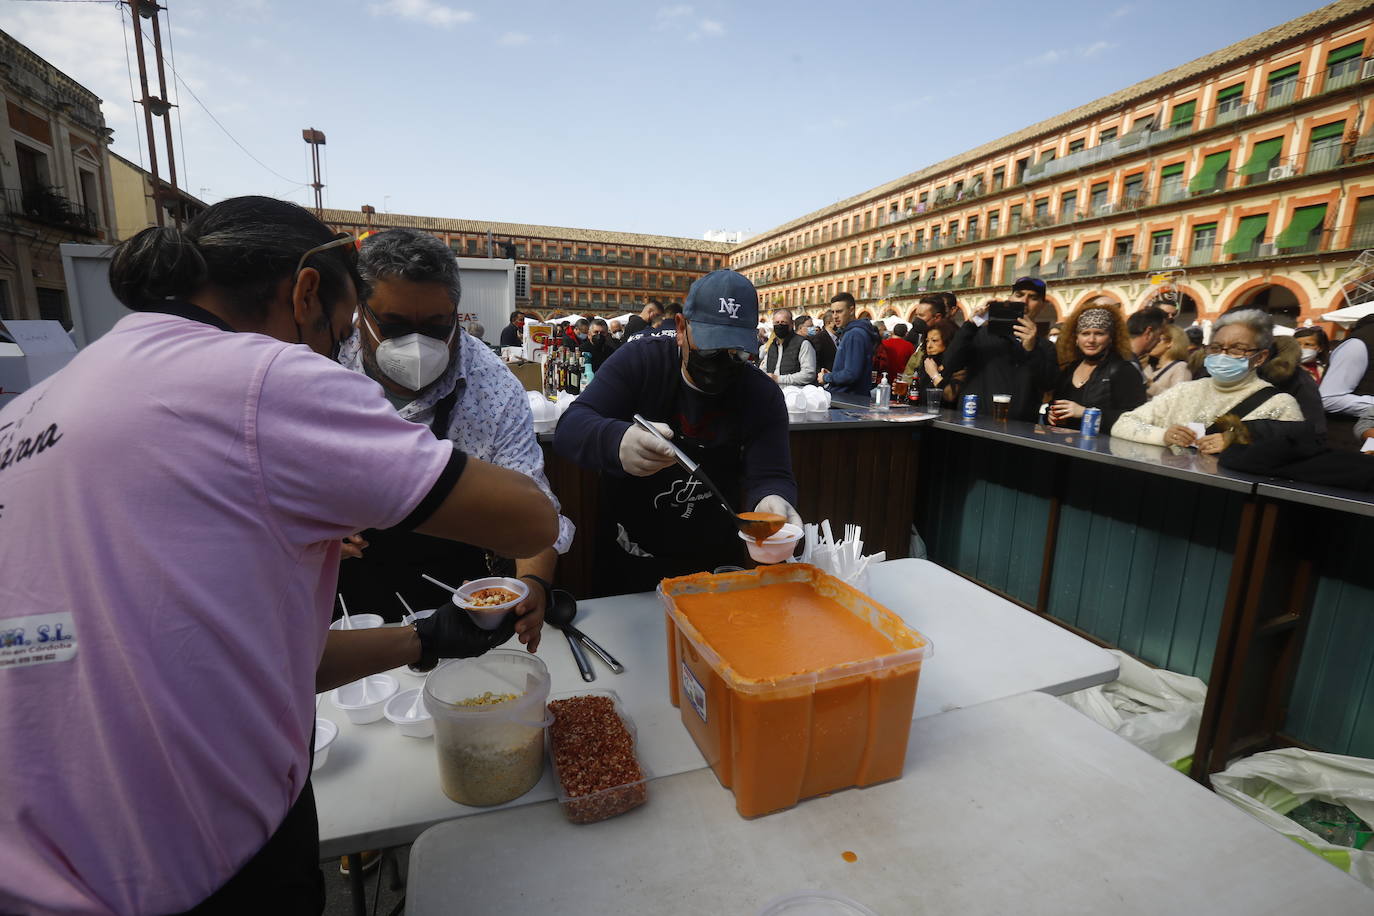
[1059,650,1206,772]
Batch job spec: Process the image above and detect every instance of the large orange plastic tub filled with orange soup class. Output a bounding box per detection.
[658,563,929,817]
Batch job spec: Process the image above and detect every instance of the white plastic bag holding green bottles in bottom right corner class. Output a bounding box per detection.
[1212,747,1374,887]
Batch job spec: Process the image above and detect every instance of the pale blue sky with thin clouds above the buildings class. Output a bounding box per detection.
[0,0,1318,238]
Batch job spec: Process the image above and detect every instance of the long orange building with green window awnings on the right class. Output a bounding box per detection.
[731,1,1374,325]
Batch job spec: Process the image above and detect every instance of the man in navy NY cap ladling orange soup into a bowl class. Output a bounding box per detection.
[554,269,801,595]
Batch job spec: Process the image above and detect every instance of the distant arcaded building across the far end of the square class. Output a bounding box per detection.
[323,207,735,317]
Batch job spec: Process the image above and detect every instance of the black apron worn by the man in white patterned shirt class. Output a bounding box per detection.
[338,390,515,621]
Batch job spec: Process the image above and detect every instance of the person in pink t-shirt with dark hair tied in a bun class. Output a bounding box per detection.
[0,198,556,913]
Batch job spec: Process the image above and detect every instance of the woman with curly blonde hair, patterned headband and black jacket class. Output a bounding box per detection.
[1050,297,1145,430]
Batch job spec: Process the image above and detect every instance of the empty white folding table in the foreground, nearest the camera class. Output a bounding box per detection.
[407,694,1374,916]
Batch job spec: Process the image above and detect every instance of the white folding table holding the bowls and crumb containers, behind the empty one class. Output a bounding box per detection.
[313,560,1117,860]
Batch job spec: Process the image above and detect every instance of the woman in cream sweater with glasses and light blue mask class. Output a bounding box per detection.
[1112,309,1303,455]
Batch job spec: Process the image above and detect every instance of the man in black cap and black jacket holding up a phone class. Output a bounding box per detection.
[944,277,1058,423]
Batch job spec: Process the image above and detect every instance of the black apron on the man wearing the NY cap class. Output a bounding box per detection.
[595,389,753,595]
